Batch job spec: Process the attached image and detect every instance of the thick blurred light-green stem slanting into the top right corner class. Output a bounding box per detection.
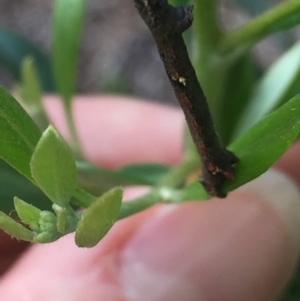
[220,0,300,54]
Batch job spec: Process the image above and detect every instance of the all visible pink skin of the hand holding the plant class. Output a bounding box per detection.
[0,96,300,301]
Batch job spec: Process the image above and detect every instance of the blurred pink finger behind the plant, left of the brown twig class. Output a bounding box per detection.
[45,96,183,167]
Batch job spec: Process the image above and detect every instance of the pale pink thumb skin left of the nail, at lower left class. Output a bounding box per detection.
[0,191,161,301]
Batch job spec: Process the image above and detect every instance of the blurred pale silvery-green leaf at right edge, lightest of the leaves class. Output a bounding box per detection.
[235,42,300,137]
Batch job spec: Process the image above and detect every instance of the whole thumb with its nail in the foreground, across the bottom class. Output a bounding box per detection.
[0,147,300,301]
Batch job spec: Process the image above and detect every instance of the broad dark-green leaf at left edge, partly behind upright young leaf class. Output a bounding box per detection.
[0,87,41,181]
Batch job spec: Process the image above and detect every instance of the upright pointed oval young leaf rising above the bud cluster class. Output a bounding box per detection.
[30,126,76,207]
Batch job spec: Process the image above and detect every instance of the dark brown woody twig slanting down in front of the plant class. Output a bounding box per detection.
[134,0,238,197]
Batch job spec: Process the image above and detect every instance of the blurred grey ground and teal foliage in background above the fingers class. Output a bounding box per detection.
[0,0,300,105]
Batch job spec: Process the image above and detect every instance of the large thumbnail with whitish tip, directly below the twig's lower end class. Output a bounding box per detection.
[120,171,300,301]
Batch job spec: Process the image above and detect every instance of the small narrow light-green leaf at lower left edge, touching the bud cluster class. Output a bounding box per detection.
[0,211,34,241]
